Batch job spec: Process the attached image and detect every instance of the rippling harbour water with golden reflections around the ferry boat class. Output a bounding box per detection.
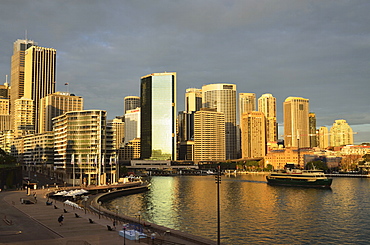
[104,174,370,245]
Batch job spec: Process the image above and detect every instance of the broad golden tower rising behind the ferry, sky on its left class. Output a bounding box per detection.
[283,97,310,148]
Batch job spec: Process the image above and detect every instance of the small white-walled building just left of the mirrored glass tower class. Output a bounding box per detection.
[124,107,141,144]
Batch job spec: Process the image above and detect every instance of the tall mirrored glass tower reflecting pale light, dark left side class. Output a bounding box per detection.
[140,72,177,160]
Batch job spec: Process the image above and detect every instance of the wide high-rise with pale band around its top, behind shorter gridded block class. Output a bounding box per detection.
[202,83,238,159]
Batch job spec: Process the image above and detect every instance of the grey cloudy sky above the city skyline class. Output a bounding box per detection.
[0,0,370,143]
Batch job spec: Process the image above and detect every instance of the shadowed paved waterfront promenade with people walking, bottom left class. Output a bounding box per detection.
[0,190,216,245]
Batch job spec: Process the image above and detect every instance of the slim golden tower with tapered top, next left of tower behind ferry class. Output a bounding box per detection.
[258,94,278,142]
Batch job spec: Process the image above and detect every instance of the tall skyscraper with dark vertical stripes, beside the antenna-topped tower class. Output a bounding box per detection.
[24,46,56,133]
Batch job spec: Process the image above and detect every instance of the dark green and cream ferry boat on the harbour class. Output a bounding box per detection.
[266,164,333,188]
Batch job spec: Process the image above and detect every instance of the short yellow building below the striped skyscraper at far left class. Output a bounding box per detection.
[13,97,35,137]
